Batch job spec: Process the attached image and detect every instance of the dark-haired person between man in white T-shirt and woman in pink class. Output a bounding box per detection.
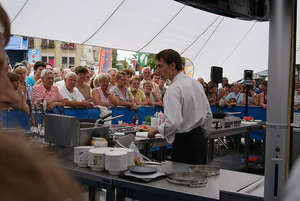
[75,66,92,100]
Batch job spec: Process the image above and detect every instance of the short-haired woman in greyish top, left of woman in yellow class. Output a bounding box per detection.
[110,72,137,110]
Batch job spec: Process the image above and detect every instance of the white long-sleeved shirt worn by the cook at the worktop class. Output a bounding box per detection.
[158,72,212,143]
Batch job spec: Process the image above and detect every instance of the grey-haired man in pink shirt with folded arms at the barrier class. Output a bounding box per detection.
[31,69,65,111]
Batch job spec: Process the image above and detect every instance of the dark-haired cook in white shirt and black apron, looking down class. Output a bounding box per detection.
[148,49,212,164]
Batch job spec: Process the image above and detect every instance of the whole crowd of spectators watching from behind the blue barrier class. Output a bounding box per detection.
[7,58,276,113]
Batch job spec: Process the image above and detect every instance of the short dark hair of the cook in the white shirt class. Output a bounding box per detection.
[155,49,183,71]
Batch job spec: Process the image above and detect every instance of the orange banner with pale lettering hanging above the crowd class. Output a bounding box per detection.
[98,47,112,74]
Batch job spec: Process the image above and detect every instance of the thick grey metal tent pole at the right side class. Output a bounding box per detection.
[264,0,296,200]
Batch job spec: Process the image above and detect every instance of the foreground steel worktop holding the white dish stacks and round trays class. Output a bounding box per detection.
[58,159,264,201]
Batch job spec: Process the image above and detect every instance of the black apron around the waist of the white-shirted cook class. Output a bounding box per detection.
[172,126,207,165]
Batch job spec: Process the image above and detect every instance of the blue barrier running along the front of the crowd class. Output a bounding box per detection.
[1,106,268,140]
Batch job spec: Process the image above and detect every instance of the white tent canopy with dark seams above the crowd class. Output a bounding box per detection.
[1,0,300,82]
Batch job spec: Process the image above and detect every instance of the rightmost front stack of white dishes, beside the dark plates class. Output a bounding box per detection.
[105,150,128,175]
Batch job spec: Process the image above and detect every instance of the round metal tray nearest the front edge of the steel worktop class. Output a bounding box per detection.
[167,172,207,187]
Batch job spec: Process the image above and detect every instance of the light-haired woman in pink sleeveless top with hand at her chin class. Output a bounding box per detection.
[92,73,118,107]
